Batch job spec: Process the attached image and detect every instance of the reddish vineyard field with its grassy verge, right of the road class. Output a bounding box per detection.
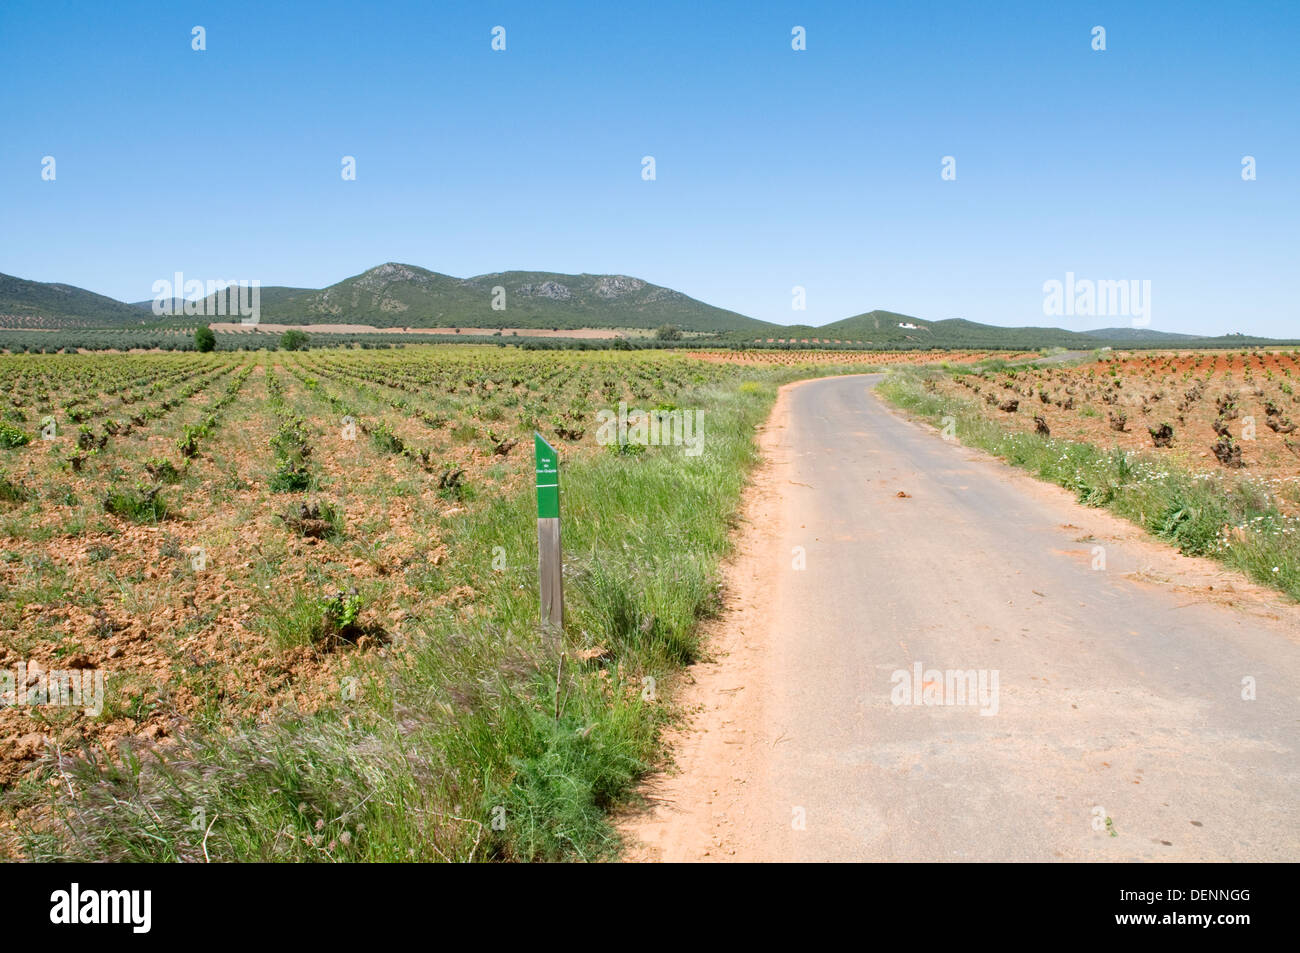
[881,351,1300,599]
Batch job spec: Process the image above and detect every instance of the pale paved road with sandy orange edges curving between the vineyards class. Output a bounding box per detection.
[624,377,1300,861]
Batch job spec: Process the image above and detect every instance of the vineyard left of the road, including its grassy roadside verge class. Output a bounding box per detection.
[0,346,883,859]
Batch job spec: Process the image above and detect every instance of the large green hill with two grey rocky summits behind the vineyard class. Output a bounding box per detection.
[239,261,776,332]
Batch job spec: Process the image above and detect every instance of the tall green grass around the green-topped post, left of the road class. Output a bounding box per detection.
[7,367,832,862]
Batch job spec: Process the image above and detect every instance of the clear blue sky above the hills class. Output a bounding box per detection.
[0,0,1300,335]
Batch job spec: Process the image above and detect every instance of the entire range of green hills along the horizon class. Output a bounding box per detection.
[0,261,1281,348]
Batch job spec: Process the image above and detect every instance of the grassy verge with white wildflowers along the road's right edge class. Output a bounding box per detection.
[878,369,1300,601]
